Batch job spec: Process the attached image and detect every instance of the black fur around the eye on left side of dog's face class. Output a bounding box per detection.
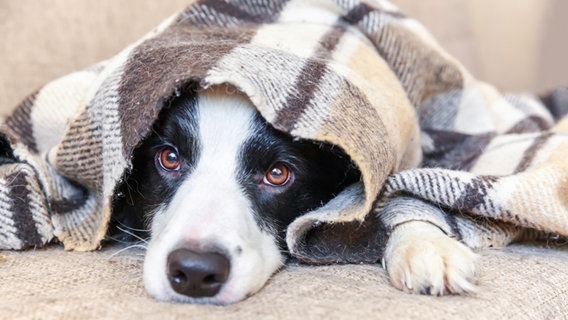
[109,93,200,240]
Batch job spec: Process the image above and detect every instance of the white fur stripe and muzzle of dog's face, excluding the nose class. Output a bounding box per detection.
[144,92,283,304]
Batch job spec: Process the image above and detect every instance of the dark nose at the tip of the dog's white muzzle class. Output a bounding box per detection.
[168,249,230,298]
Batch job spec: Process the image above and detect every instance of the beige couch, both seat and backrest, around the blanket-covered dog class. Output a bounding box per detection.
[0,0,568,319]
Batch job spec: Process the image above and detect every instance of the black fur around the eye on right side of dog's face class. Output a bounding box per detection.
[239,114,359,242]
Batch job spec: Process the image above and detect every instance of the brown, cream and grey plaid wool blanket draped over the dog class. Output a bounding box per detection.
[0,0,568,263]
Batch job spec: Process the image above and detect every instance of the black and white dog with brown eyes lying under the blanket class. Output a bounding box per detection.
[113,87,475,305]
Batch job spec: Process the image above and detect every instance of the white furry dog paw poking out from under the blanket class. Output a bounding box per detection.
[383,221,477,295]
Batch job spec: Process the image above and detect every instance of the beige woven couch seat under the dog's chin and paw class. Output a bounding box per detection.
[0,245,568,319]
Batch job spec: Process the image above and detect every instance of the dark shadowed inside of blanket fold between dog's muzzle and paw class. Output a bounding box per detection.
[293,209,389,264]
